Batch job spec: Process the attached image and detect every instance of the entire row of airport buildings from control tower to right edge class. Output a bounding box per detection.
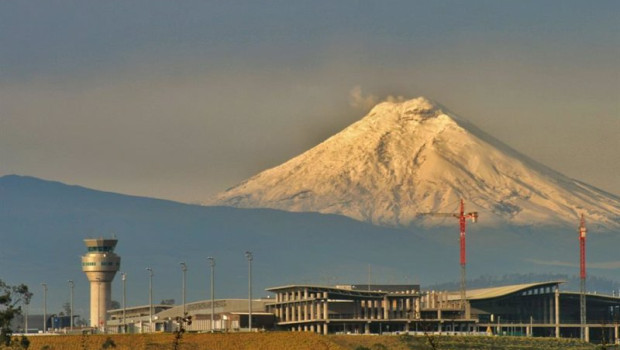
[100,281,620,343]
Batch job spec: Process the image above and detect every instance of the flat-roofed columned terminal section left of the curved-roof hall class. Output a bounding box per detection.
[267,285,475,334]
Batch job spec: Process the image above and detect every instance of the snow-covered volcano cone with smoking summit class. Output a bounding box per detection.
[214,97,620,229]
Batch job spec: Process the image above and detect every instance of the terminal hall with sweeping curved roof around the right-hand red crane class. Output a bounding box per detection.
[464,281,620,343]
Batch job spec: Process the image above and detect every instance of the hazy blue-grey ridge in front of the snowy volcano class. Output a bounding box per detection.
[0,175,618,316]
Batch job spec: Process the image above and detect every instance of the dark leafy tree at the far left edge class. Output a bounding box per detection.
[0,280,32,346]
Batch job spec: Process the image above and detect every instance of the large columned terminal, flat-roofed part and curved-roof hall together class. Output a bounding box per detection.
[266,281,620,343]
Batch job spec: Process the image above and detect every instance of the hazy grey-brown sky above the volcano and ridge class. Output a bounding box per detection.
[0,0,620,202]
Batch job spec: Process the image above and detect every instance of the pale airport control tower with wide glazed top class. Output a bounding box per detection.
[82,238,121,330]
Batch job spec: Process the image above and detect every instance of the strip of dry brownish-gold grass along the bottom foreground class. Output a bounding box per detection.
[12,332,611,350]
